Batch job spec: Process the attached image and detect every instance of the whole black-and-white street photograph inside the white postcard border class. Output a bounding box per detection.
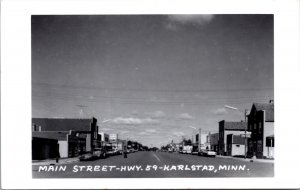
[28,14,276,178]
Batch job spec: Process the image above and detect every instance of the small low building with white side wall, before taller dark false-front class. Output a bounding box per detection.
[226,134,245,156]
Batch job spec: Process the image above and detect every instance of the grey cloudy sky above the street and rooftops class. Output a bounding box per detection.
[32,15,274,146]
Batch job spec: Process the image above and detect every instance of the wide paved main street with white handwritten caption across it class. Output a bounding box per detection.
[32,151,274,178]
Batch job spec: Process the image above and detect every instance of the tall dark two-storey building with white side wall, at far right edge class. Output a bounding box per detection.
[248,100,275,158]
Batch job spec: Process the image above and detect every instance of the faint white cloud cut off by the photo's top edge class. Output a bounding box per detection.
[167,14,214,25]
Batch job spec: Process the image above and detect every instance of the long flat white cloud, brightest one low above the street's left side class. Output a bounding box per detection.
[111,117,159,125]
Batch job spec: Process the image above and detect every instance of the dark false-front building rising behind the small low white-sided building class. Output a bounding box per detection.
[219,120,247,155]
